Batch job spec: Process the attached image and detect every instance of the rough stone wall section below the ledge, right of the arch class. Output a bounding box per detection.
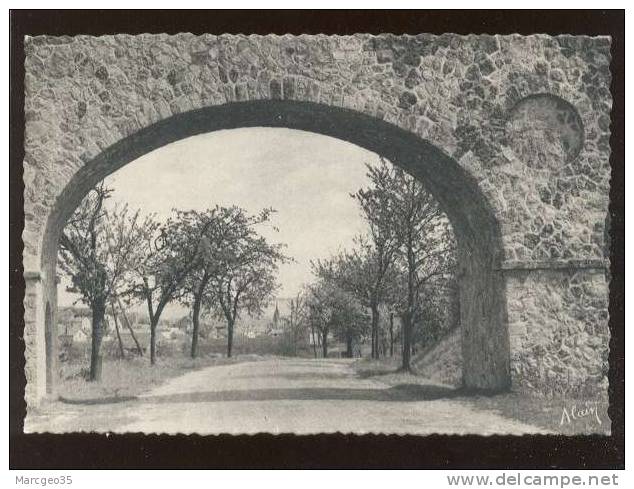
[507,269,610,399]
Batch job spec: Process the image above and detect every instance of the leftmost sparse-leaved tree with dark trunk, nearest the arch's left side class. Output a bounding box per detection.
[59,182,154,380]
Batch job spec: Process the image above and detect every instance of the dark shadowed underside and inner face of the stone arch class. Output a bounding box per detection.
[41,100,511,390]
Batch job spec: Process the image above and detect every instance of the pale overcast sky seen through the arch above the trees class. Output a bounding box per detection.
[59,128,378,305]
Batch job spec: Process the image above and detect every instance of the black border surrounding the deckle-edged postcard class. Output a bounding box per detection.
[9,10,625,469]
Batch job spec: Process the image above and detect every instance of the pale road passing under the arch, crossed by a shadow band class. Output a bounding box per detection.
[28,359,543,435]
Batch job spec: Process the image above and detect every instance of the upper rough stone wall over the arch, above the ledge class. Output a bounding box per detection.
[24,34,611,400]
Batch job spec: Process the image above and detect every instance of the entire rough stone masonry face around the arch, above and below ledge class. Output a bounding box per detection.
[23,34,611,405]
